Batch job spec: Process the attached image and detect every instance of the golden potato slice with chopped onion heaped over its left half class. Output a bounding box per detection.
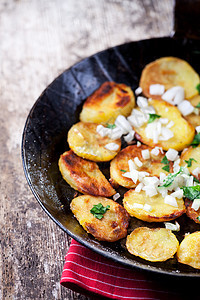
[134,100,195,151]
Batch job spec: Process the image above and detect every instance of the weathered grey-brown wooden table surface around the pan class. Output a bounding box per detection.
[0,0,174,300]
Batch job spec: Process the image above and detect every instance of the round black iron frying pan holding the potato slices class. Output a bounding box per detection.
[22,1,200,278]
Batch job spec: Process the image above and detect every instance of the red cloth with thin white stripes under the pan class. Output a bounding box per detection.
[60,240,199,300]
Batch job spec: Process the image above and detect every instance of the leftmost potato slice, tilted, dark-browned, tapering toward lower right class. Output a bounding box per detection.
[58,150,116,197]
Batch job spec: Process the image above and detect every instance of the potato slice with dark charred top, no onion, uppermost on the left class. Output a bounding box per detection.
[80,81,135,124]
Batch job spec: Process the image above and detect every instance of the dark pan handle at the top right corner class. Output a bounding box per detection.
[174,0,200,39]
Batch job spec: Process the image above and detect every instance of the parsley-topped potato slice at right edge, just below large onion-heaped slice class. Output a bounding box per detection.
[180,145,200,180]
